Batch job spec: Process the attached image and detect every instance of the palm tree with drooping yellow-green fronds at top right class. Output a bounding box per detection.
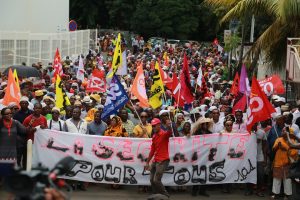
[205,0,300,68]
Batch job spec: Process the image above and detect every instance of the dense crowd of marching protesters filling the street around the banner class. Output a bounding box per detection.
[0,34,300,199]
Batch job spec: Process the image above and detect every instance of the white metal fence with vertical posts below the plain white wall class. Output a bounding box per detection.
[0,29,97,70]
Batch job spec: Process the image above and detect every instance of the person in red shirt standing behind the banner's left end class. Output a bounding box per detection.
[23,103,47,142]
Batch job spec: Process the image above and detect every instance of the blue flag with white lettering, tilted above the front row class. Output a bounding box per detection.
[101,76,129,119]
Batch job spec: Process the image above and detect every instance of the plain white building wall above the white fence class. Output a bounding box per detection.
[0,0,69,33]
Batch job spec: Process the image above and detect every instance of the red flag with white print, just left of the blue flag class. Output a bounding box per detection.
[86,69,106,92]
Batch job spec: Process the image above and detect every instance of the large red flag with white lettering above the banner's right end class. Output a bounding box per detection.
[247,77,275,133]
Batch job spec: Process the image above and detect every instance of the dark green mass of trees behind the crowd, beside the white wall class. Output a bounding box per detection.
[70,0,223,40]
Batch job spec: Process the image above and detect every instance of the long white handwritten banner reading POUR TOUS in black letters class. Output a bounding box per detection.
[33,129,257,186]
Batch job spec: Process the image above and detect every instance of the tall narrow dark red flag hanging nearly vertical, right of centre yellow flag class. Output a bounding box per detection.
[180,54,194,104]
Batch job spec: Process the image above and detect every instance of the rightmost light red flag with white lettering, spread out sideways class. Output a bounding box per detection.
[259,75,285,96]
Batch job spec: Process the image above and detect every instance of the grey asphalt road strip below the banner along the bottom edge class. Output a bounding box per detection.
[0,184,270,200]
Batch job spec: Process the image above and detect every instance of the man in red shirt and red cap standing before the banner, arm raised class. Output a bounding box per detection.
[145,118,172,197]
